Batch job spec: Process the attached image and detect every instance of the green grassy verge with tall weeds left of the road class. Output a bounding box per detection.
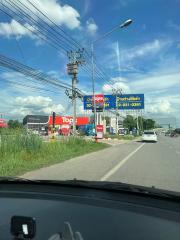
[0,130,108,176]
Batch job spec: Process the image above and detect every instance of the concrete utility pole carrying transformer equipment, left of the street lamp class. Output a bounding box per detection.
[66,49,85,136]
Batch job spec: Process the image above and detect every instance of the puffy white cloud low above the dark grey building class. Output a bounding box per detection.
[11,96,64,116]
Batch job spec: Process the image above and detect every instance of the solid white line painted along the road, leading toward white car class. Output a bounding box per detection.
[100,143,145,181]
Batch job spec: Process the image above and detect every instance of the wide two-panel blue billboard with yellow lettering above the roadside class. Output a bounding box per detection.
[83,94,144,110]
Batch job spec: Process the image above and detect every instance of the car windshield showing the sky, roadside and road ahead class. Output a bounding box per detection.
[0,0,180,192]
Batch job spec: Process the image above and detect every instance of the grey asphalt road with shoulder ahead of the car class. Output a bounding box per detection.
[23,136,180,191]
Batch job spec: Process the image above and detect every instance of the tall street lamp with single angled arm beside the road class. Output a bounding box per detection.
[91,19,132,137]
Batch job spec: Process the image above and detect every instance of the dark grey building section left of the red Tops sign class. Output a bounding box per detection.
[23,115,49,132]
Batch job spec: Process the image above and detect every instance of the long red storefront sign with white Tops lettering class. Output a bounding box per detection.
[48,116,89,126]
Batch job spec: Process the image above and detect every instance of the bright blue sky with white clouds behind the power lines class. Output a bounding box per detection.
[0,0,180,125]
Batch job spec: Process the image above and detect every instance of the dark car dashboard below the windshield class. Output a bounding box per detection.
[0,182,180,240]
